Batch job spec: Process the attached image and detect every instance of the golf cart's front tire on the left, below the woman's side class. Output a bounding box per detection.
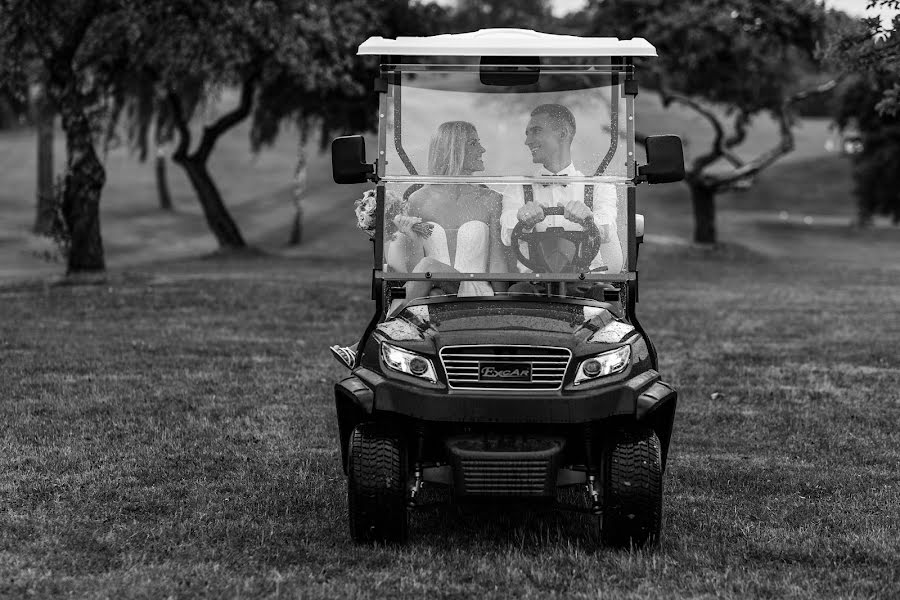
[347,423,409,544]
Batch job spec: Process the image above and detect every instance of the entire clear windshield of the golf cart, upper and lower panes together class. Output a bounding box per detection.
[379,65,633,284]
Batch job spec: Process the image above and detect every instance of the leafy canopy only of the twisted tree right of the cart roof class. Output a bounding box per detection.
[592,0,824,113]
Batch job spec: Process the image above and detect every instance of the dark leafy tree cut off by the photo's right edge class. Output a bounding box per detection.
[827,0,900,225]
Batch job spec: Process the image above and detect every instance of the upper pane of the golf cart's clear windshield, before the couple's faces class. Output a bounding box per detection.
[379,65,629,178]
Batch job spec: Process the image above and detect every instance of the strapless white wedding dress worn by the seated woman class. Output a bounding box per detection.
[422,221,494,296]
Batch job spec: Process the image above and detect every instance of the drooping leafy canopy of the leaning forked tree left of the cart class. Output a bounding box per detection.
[114,0,446,157]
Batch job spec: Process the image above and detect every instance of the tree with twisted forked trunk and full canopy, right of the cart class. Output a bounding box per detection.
[589,0,834,244]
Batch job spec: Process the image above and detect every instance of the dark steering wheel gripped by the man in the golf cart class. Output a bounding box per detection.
[510,206,608,273]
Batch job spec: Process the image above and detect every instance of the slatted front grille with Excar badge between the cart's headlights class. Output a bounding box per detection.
[440,345,572,390]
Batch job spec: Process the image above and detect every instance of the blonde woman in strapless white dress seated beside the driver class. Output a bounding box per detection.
[386,121,507,299]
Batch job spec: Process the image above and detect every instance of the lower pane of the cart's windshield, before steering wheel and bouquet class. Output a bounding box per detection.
[382,182,629,282]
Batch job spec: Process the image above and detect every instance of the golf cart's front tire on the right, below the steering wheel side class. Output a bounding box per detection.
[600,428,662,548]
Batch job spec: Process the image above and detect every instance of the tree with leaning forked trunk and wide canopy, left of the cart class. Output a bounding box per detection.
[111,0,443,248]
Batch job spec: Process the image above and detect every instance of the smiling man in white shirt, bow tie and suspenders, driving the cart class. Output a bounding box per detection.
[500,104,623,292]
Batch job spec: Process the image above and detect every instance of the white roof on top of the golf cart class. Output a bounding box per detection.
[357,29,656,56]
